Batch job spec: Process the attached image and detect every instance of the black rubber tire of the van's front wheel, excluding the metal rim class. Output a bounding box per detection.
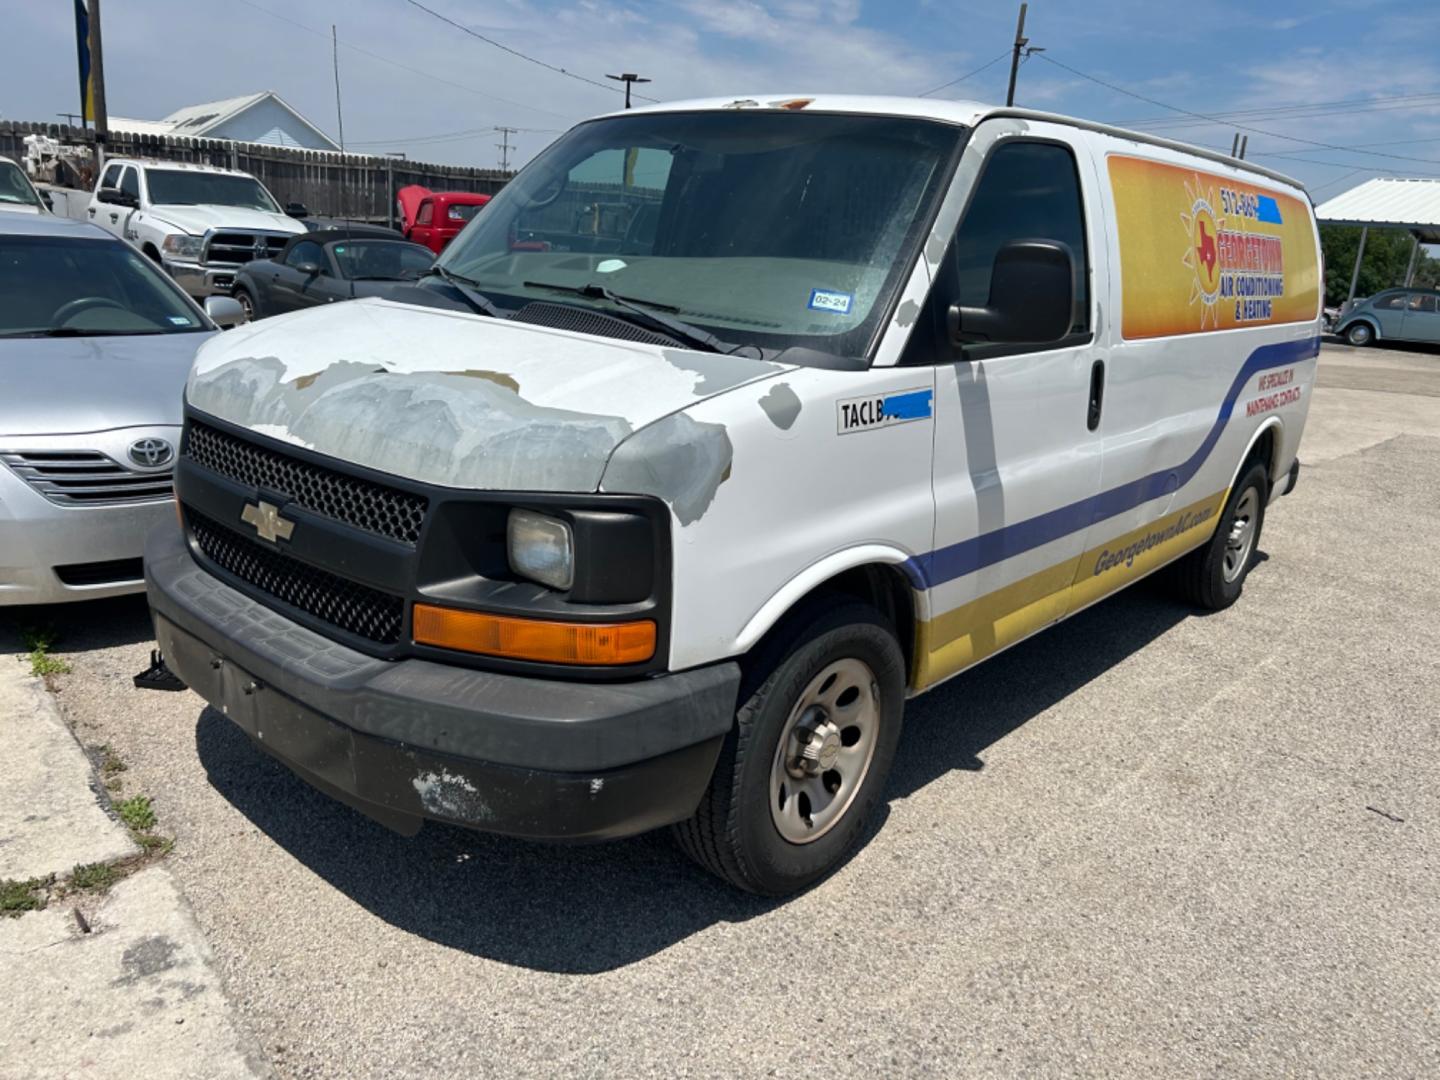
[674,600,906,896]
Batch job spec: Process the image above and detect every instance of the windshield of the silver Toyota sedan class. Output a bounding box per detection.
[0,236,209,337]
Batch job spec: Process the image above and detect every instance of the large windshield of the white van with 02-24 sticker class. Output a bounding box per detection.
[441,111,963,356]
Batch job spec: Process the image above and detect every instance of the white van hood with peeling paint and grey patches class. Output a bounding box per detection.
[186,300,793,491]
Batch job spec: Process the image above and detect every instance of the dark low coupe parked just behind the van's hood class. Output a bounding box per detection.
[232,226,435,318]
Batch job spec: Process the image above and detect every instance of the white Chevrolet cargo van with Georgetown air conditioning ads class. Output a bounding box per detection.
[147,96,1320,893]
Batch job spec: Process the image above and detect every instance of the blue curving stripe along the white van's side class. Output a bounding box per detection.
[901,337,1320,589]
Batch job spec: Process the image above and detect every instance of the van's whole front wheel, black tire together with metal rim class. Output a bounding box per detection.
[675,602,904,896]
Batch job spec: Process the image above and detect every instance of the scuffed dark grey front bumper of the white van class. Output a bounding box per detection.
[145,523,740,840]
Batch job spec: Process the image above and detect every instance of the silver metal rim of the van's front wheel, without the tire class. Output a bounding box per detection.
[770,658,883,844]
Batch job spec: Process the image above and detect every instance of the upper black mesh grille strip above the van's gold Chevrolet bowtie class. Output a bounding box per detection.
[184,420,426,547]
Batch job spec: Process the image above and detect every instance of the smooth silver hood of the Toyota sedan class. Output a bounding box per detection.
[0,333,216,438]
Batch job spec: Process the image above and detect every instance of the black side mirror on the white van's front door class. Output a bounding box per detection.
[946,240,1076,346]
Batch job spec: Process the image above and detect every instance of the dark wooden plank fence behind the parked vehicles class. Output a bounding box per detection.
[0,120,513,222]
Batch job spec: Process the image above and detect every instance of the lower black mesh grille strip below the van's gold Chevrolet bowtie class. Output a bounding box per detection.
[186,507,405,645]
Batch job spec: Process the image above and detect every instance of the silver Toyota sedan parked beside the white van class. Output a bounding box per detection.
[0,213,240,605]
